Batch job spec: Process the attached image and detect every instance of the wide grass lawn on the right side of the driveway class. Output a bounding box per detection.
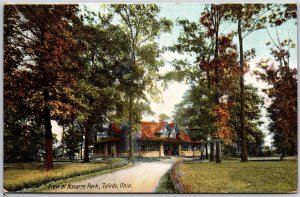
[178,160,297,193]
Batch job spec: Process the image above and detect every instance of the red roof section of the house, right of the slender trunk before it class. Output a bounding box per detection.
[141,121,191,142]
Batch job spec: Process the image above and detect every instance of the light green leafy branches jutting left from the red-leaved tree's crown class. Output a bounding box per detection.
[164,19,214,86]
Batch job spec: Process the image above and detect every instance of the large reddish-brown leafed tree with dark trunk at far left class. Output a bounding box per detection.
[4,5,80,169]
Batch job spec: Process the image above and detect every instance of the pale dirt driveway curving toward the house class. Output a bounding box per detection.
[46,159,175,193]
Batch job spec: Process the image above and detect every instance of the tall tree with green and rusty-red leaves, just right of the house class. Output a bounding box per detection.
[167,5,237,163]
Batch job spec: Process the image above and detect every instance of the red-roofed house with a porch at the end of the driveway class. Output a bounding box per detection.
[94,120,203,157]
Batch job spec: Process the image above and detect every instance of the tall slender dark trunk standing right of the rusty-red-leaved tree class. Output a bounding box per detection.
[238,15,248,162]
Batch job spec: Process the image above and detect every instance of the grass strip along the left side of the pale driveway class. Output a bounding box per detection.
[4,159,127,191]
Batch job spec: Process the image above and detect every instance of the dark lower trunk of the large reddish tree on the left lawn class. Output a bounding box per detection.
[43,89,53,170]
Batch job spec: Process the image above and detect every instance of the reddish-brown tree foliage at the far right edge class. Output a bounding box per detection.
[257,58,297,156]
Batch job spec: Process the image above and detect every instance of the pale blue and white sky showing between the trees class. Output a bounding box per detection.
[52,3,297,145]
